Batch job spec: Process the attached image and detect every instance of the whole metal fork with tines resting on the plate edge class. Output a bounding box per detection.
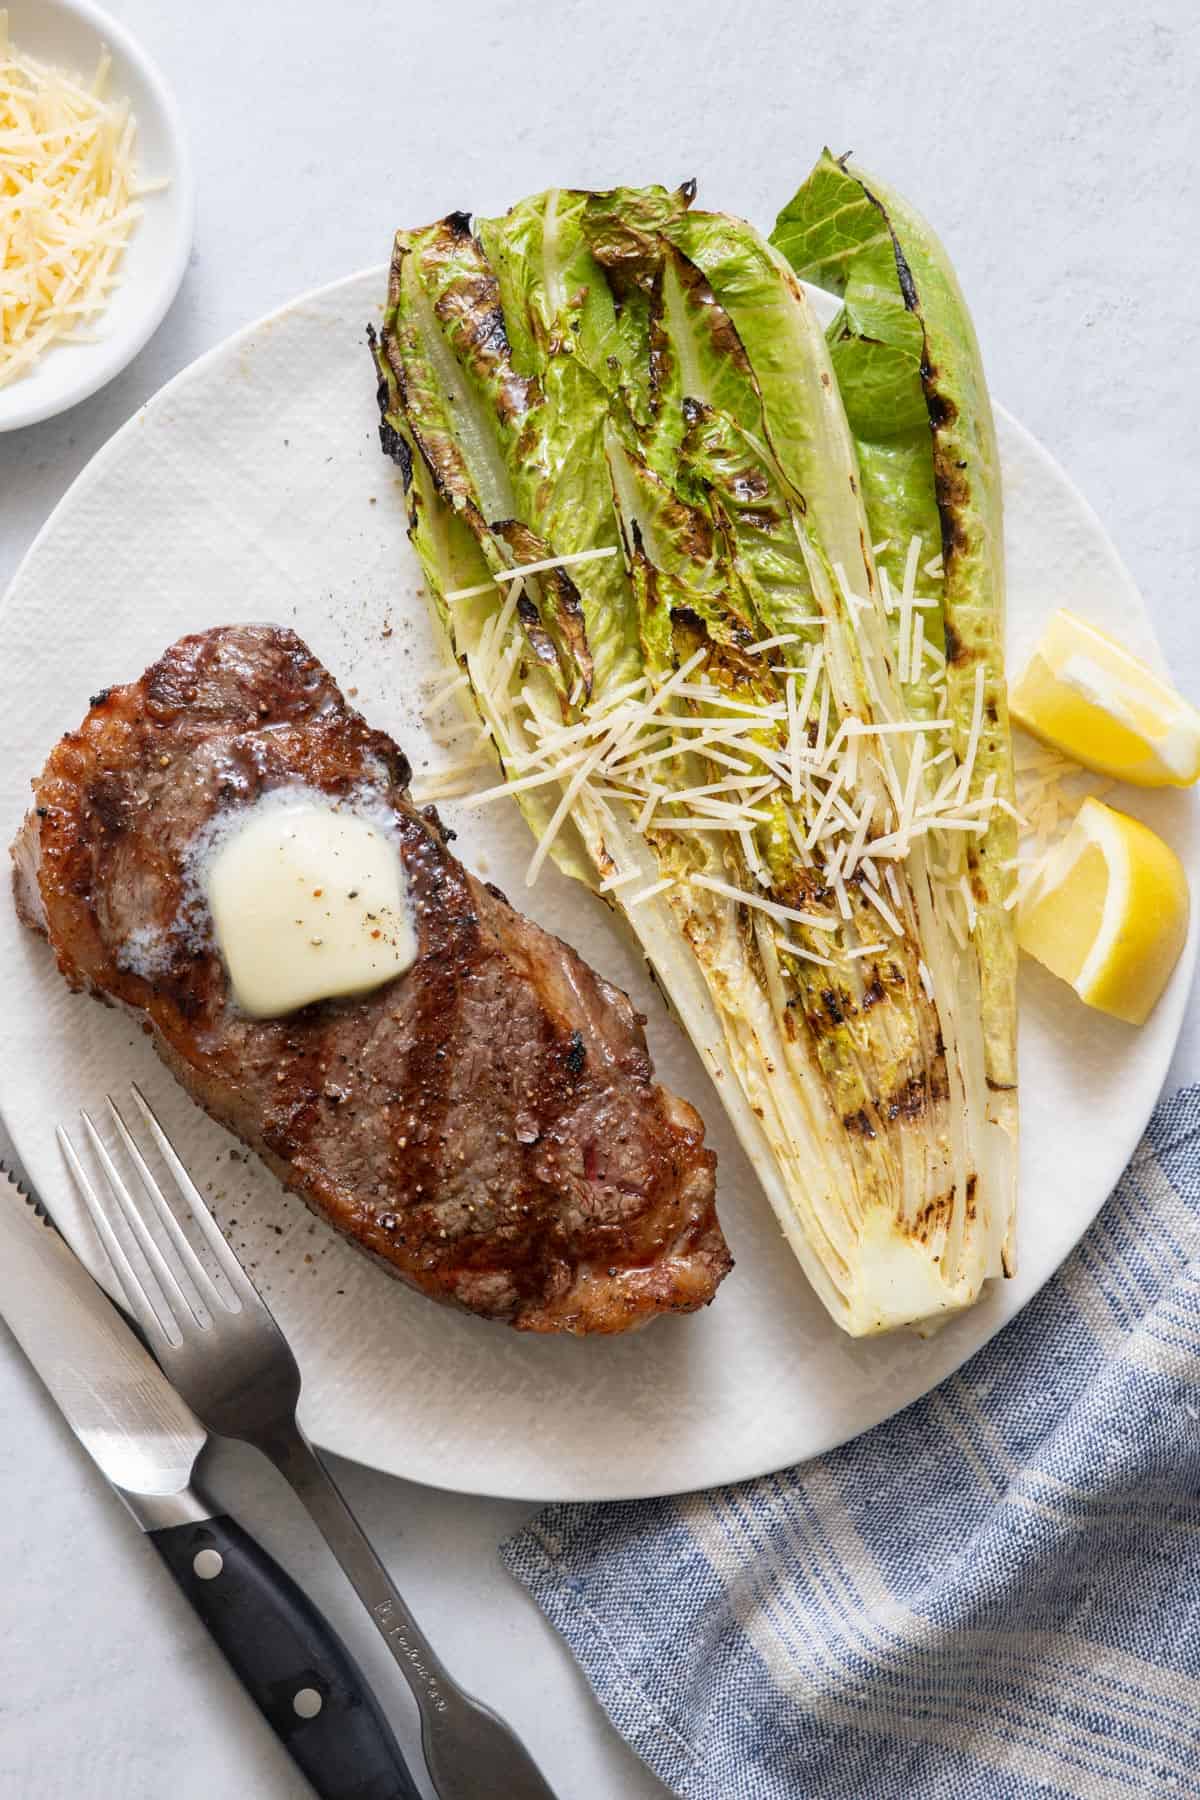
[67,1085,554,1800]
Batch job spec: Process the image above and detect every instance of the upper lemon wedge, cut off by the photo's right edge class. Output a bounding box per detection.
[1009,610,1200,787]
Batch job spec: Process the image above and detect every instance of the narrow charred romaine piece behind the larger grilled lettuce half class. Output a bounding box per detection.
[772,149,1016,1264]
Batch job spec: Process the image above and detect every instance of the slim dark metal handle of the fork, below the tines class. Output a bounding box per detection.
[254,1424,554,1800]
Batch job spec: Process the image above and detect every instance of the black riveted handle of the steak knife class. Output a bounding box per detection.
[146,1514,419,1800]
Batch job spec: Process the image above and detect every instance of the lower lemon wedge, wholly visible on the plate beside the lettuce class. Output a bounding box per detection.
[1016,797,1189,1024]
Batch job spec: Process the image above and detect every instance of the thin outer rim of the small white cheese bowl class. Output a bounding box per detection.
[0,0,196,432]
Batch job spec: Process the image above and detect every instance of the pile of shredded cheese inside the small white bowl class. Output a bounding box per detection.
[0,9,166,387]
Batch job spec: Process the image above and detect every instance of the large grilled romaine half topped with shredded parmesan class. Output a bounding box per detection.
[376,171,1015,1334]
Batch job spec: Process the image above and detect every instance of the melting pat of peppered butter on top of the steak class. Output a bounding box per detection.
[205,796,417,1019]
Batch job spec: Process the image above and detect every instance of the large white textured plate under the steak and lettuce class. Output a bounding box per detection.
[0,270,1198,1499]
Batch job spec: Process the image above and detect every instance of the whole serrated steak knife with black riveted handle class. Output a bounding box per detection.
[0,1165,419,1800]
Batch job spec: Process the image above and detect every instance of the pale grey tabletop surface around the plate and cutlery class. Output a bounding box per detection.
[0,0,1200,1800]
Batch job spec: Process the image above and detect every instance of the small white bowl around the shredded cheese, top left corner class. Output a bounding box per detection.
[0,0,194,432]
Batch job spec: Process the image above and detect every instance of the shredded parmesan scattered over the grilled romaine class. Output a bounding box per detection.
[417,511,1029,1003]
